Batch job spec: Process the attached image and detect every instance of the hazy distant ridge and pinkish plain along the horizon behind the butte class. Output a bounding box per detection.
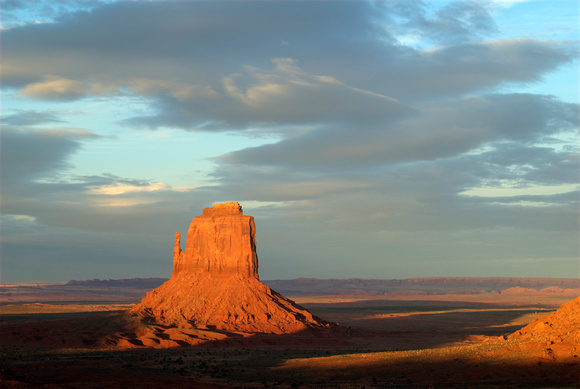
[0,277,580,305]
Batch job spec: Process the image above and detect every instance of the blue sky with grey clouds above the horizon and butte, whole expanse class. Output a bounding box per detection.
[0,0,580,283]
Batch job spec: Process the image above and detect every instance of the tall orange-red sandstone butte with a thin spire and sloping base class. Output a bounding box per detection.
[130,202,328,334]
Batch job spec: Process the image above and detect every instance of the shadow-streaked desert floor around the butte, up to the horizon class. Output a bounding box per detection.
[0,279,580,388]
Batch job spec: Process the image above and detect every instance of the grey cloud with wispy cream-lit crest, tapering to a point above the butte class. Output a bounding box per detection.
[129,58,412,130]
